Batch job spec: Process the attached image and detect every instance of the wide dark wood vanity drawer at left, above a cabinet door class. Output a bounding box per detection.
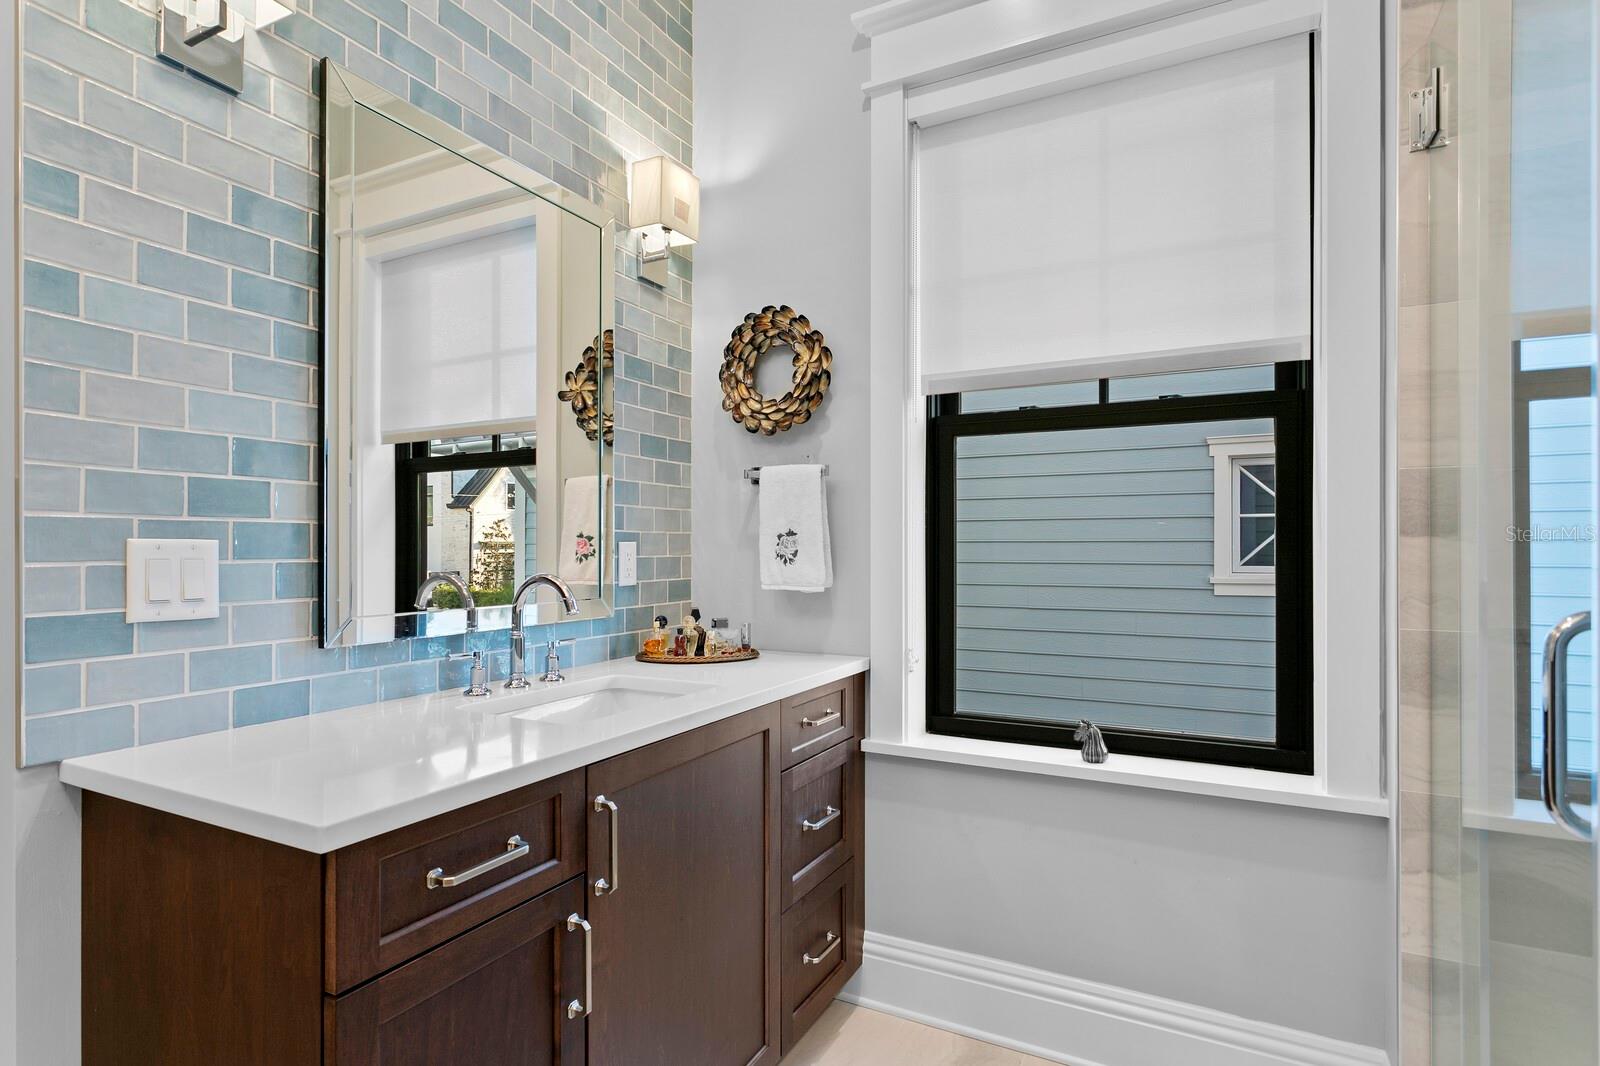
[323,770,586,992]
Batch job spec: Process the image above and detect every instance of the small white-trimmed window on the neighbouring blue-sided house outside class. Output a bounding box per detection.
[1206,435,1278,595]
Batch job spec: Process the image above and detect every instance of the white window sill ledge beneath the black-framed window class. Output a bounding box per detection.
[861,735,1389,818]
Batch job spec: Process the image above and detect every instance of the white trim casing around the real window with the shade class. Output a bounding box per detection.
[856,0,1397,806]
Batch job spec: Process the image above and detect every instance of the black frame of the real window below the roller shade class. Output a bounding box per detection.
[926,362,1315,775]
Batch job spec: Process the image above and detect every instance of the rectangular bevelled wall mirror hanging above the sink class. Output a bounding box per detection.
[322,62,616,647]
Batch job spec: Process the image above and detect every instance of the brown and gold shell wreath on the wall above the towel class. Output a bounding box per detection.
[718,304,834,437]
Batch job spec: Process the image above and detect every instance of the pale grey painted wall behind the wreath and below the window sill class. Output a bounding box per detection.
[693,0,1394,1047]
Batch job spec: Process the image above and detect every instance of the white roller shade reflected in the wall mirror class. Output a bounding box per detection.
[376,222,539,443]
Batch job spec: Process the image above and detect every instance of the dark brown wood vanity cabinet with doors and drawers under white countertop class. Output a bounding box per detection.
[83,677,864,1066]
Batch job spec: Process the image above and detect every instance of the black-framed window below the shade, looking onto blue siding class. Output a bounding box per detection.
[928,362,1312,773]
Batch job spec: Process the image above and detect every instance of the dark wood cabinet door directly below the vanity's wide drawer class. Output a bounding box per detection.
[323,877,592,1066]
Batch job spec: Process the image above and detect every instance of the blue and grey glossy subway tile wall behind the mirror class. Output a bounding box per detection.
[19,0,693,763]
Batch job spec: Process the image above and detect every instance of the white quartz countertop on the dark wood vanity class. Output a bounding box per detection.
[61,651,867,853]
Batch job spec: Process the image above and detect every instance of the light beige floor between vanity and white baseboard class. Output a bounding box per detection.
[784,1002,1051,1066]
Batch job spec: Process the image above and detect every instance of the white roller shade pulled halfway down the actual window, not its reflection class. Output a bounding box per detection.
[915,37,1312,394]
